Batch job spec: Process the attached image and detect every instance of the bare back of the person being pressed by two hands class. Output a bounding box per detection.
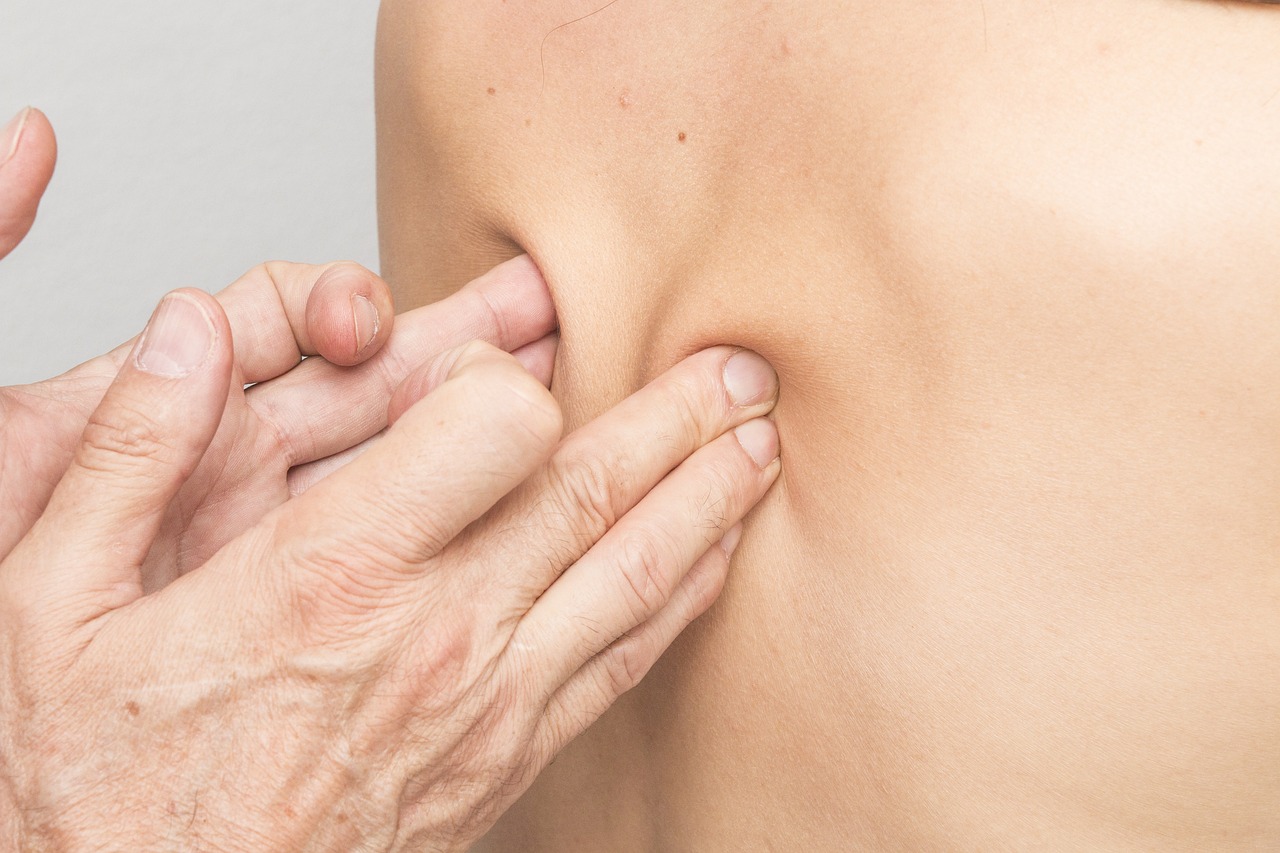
[379,0,1280,853]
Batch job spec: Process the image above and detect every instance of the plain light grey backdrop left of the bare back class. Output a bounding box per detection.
[0,0,378,386]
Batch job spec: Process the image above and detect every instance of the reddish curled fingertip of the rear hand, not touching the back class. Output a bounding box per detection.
[306,263,394,366]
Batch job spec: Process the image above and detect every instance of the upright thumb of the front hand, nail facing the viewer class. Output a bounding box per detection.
[15,289,232,621]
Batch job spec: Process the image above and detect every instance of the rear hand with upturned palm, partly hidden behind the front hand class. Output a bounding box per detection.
[0,110,556,590]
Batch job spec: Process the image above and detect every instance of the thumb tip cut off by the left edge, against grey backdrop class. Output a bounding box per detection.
[0,106,58,257]
